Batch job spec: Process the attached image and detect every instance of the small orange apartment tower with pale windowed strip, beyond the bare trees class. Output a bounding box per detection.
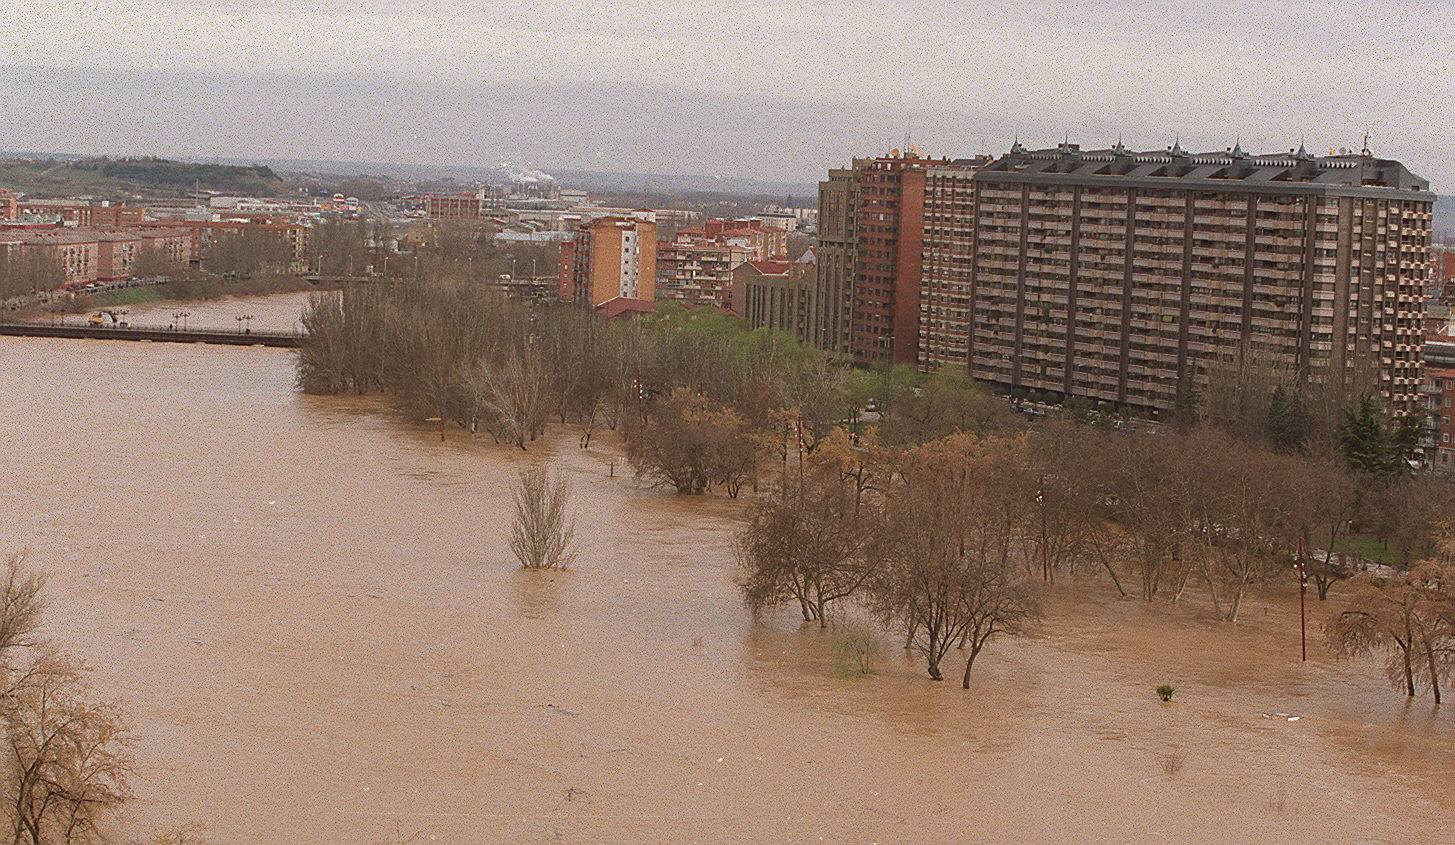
[559,211,656,305]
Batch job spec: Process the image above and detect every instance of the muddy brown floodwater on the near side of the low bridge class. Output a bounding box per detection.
[0,295,1455,844]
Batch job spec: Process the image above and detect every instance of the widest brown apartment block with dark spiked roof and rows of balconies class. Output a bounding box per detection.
[969,144,1435,413]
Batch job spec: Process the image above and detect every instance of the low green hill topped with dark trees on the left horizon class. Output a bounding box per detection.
[0,157,284,199]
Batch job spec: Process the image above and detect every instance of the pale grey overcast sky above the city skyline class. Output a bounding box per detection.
[0,0,1455,192]
